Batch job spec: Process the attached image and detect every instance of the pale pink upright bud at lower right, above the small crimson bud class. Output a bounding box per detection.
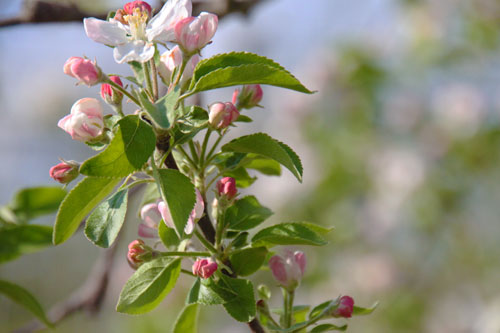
[269,250,306,290]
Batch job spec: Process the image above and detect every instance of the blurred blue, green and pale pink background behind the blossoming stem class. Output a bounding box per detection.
[0,0,500,333]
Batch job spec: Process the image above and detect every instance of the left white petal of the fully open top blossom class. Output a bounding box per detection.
[83,17,128,46]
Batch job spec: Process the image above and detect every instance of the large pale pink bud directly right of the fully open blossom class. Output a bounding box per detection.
[174,12,218,54]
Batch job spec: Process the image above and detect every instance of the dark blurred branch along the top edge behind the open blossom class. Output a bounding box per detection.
[0,0,263,28]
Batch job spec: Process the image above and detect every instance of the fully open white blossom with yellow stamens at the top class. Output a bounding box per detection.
[83,0,192,64]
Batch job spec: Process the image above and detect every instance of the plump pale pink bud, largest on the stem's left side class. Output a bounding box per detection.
[57,98,104,142]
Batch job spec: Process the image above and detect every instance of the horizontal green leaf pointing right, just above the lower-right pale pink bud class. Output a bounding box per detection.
[252,222,327,246]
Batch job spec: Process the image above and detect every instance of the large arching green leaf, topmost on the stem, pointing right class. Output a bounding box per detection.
[189,52,312,94]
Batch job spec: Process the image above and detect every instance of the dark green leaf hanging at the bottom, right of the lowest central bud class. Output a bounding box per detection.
[219,275,256,323]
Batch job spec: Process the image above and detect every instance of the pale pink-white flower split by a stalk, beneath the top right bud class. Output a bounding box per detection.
[158,45,200,84]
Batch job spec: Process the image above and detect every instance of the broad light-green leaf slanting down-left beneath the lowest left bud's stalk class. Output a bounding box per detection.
[116,257,181,314]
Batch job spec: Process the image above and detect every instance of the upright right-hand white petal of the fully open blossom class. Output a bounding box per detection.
[146,0,192,43]
